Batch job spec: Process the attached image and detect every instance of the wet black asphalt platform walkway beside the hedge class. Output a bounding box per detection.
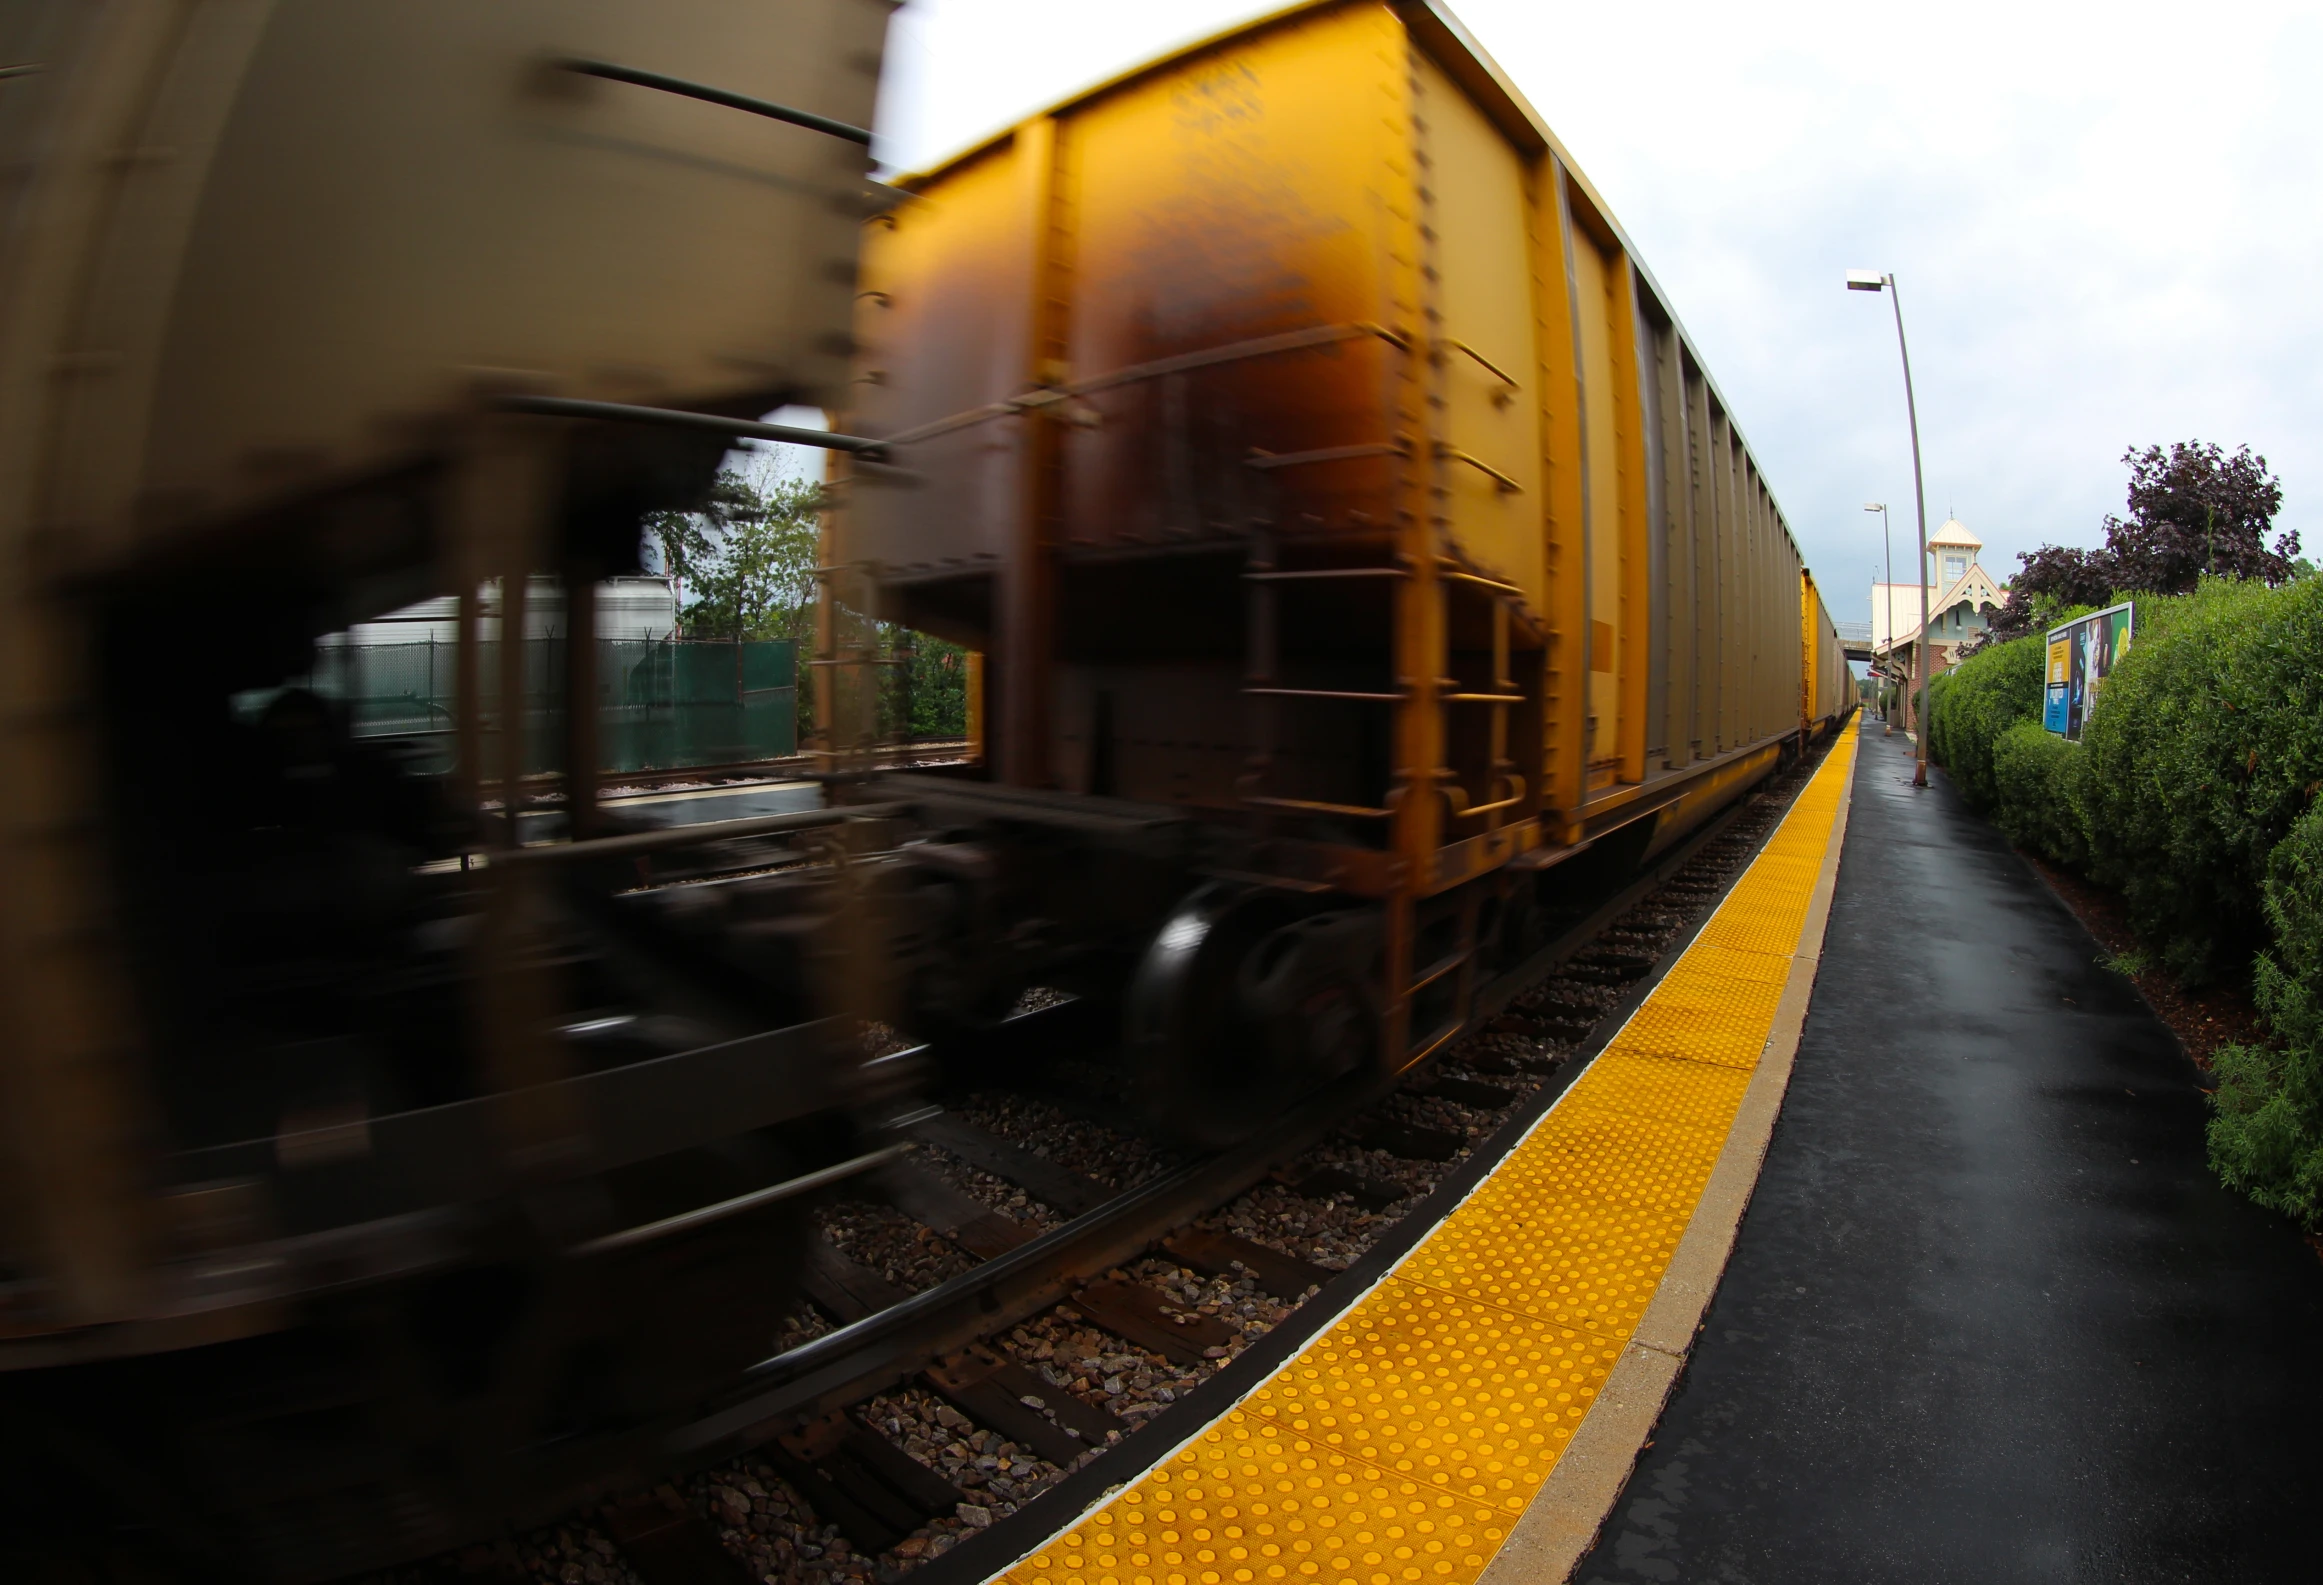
[1573,720,2323,1585]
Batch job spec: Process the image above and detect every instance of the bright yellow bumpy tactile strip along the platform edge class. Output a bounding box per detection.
[999,725,1856,1585]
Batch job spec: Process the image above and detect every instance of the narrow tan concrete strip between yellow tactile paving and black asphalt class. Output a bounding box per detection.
[1477,725,1861,1585]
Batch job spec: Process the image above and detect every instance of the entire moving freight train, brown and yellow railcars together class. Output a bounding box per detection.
[0,0,1851,1580]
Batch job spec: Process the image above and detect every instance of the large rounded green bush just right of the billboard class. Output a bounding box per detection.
[2077,579,2323,983]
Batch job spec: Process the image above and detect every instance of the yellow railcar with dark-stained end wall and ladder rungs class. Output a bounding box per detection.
[820,0,1849,1136]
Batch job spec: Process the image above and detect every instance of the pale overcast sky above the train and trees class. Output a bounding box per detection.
[826,0,2323,621]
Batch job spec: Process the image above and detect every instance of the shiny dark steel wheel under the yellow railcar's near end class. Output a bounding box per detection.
[1124,885,1380,1148]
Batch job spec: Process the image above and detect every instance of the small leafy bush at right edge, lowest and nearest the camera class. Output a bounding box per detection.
[2209,806,2323,1229]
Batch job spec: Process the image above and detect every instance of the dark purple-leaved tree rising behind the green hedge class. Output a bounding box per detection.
[1991,442,2300,644]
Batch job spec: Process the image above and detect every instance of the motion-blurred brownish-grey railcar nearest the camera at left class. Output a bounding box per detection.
[0,0,890,1580]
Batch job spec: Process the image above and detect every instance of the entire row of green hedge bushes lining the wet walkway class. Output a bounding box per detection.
[1928,579,2323,1229]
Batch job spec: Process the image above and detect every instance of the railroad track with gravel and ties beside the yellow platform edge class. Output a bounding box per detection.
[362,751,1821,1585]
